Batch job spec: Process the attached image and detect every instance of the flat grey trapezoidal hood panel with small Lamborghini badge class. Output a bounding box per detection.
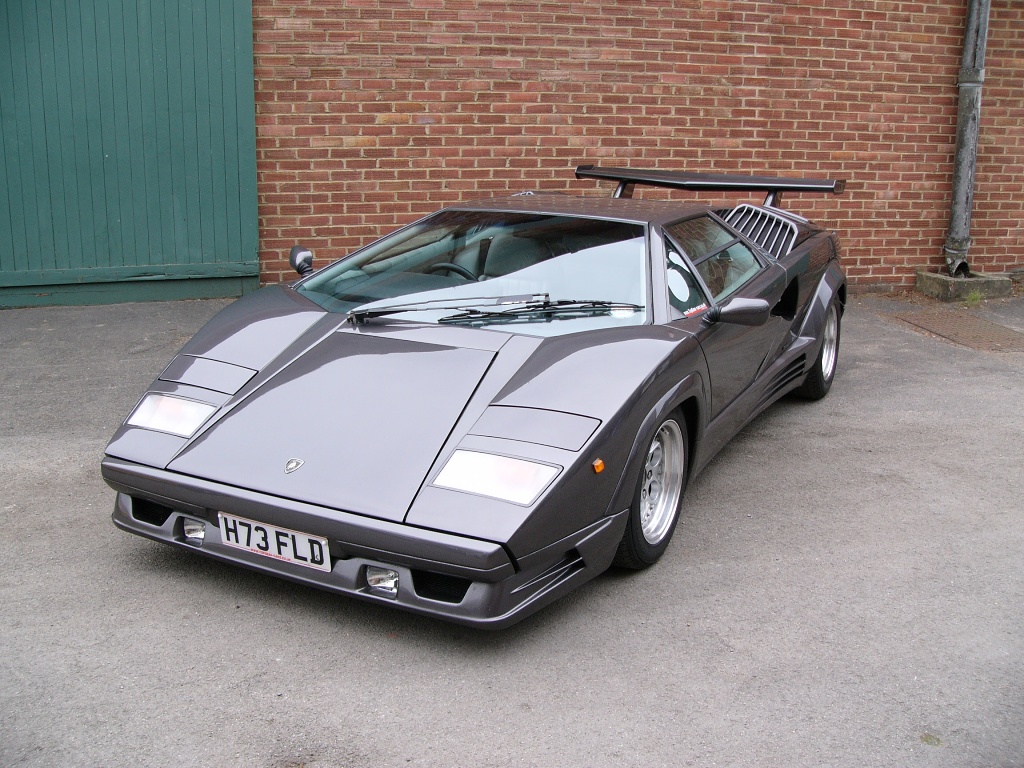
[167,330,496,521]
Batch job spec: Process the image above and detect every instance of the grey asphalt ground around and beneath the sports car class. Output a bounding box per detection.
[0,290,1024,768]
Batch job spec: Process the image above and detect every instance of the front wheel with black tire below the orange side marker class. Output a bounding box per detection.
[612,416,688,570]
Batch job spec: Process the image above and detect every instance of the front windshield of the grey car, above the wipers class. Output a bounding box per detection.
[297,211,647,336]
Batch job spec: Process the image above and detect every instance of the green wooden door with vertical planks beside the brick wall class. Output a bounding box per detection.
[0,0,259,306]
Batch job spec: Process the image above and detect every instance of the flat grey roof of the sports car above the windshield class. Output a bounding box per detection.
[446,191,713,224]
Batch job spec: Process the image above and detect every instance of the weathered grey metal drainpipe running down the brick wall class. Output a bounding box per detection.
[942,0,991,278]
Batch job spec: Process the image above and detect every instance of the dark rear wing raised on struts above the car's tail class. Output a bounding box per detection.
[577,165,846,206]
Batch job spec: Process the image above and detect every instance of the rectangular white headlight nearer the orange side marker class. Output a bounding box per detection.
[433,451,561,504]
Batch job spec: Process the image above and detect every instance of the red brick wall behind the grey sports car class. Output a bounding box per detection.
[254,0,1024,290]
